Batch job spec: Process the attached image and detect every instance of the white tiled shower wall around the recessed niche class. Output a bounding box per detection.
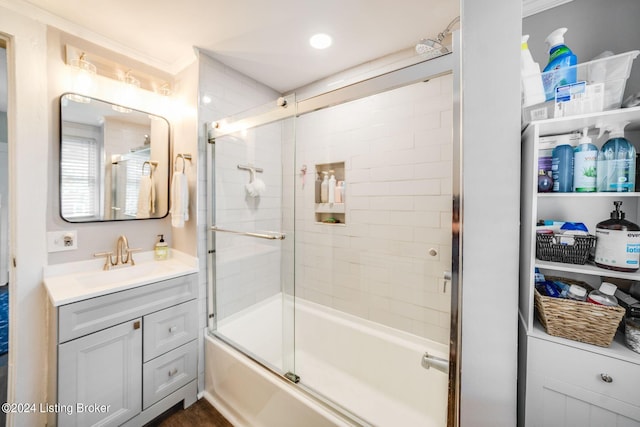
[295,75,453,343]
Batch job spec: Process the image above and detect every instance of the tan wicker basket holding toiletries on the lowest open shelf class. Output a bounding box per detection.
[534,277,625,347]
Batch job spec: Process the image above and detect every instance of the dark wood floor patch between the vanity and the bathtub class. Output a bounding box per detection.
[145,399,233,427]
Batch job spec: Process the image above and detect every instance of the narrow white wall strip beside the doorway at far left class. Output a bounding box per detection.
[0,6,49,426]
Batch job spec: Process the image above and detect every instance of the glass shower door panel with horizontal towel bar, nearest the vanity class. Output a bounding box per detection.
[208,110,294,378]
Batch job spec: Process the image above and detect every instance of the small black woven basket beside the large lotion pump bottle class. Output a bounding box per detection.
[536,233,596,264]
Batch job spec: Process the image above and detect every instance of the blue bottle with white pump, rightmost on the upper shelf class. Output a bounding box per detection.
[596,122,636,192]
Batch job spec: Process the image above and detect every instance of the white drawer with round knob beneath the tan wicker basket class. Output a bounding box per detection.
[528,339,640,410]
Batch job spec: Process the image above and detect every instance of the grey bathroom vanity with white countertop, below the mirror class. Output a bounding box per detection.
[45,254,198,426]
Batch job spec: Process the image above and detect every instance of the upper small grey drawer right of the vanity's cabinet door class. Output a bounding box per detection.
[143,300,198,362]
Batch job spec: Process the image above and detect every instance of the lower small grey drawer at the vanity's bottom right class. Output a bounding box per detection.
[142,340,198,409]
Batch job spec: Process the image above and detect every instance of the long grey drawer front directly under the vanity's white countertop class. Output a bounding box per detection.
[58,274,198,343]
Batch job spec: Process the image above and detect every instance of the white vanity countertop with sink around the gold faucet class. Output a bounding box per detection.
[43,249,198,307]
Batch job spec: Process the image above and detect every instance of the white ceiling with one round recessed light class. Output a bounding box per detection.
[13,0,459,93]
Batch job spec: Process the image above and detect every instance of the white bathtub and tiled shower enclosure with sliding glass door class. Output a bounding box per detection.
[205,47,460,427]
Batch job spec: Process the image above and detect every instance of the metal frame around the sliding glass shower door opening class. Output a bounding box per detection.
[205,42,462,427]
